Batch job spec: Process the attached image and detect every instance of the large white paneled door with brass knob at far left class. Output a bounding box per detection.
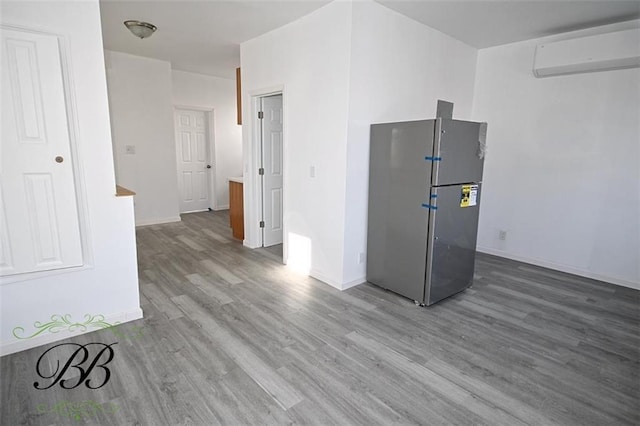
[0,28,83,276]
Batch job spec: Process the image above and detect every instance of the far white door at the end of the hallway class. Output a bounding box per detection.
[175,109,211,213]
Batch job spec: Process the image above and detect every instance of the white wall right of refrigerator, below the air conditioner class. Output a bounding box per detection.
[473,19,640,288]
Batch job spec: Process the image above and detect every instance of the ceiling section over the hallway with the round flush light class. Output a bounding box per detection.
[100,0,329,78]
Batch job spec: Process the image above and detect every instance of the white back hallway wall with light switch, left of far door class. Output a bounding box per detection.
[104,50,180,225]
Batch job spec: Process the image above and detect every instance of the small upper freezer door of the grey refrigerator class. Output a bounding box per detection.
[432,118,484,186]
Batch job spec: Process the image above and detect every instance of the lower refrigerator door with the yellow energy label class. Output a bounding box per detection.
[424,183,480,306]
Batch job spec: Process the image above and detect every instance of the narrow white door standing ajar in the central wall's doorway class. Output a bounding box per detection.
[260,95,283,247]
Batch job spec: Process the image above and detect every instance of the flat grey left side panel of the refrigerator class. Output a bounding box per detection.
[367,120,435,302]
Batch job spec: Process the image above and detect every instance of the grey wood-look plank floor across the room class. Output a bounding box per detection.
[0,212,640,425]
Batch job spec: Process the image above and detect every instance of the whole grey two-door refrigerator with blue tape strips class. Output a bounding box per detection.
[367,113,487,306]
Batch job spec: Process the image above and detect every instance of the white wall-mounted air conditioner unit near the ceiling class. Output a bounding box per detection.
[533,28,640,77]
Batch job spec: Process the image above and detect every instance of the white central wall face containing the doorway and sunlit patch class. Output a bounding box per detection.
[240,2,351,287]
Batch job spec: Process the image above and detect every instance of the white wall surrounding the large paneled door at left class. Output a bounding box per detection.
[0,1,142,354]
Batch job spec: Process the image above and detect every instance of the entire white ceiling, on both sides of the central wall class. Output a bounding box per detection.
[100,0,640,78]
